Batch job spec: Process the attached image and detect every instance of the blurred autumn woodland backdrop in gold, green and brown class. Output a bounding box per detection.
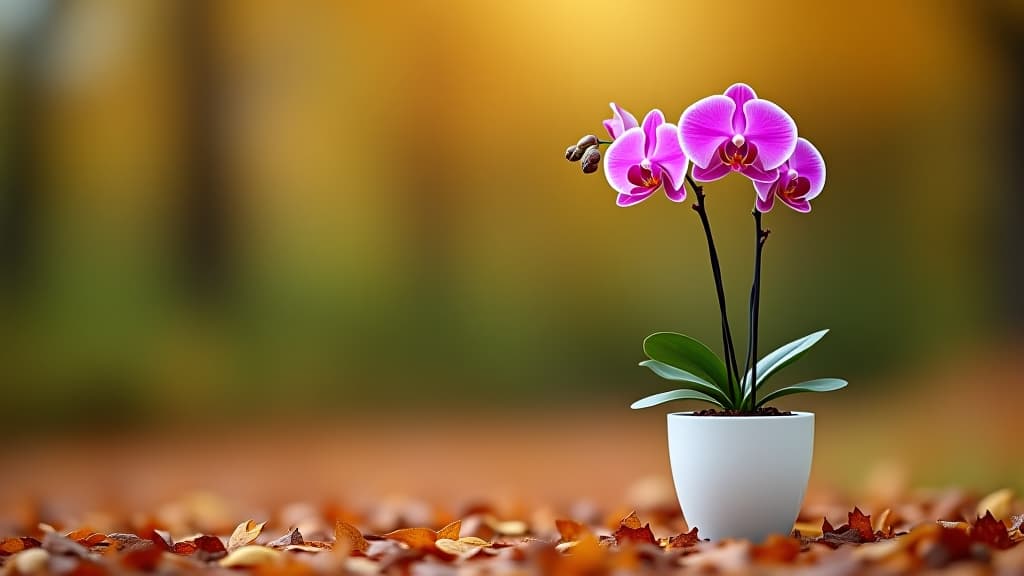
[0,0,1024,510]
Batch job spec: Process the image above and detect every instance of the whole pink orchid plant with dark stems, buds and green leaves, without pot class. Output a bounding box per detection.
[565,84,847,414]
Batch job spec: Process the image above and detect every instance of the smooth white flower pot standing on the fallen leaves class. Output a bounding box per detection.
[669,412,814,542]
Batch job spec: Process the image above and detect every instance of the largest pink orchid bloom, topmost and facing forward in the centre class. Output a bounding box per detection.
[679,84,797,182]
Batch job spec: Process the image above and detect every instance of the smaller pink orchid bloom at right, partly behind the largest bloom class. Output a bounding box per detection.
[754,138,825,213]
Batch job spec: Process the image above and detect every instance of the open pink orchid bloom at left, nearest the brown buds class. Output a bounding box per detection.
[604,105,689,206]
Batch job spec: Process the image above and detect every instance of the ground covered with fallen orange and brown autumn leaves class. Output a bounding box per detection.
[0,481,1024,576]
